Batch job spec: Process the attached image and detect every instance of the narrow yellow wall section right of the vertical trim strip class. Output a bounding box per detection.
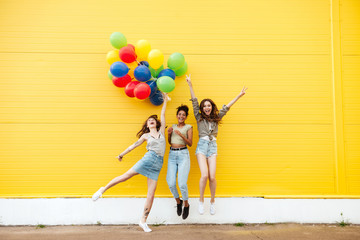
[340,0,360,195]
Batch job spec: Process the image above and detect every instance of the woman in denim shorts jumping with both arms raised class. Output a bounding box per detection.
[186,75,247,215]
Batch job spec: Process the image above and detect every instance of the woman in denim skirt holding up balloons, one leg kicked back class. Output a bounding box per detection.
[92,93,168,232]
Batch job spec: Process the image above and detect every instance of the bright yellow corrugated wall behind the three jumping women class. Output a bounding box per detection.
[0,0,360,197]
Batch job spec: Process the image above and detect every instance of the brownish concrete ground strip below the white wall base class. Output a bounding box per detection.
[0,223,360,240]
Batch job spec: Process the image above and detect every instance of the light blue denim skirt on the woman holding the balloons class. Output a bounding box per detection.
[132,151,163,181]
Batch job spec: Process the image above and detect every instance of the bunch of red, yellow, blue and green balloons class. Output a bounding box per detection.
[106,32,188,106]
